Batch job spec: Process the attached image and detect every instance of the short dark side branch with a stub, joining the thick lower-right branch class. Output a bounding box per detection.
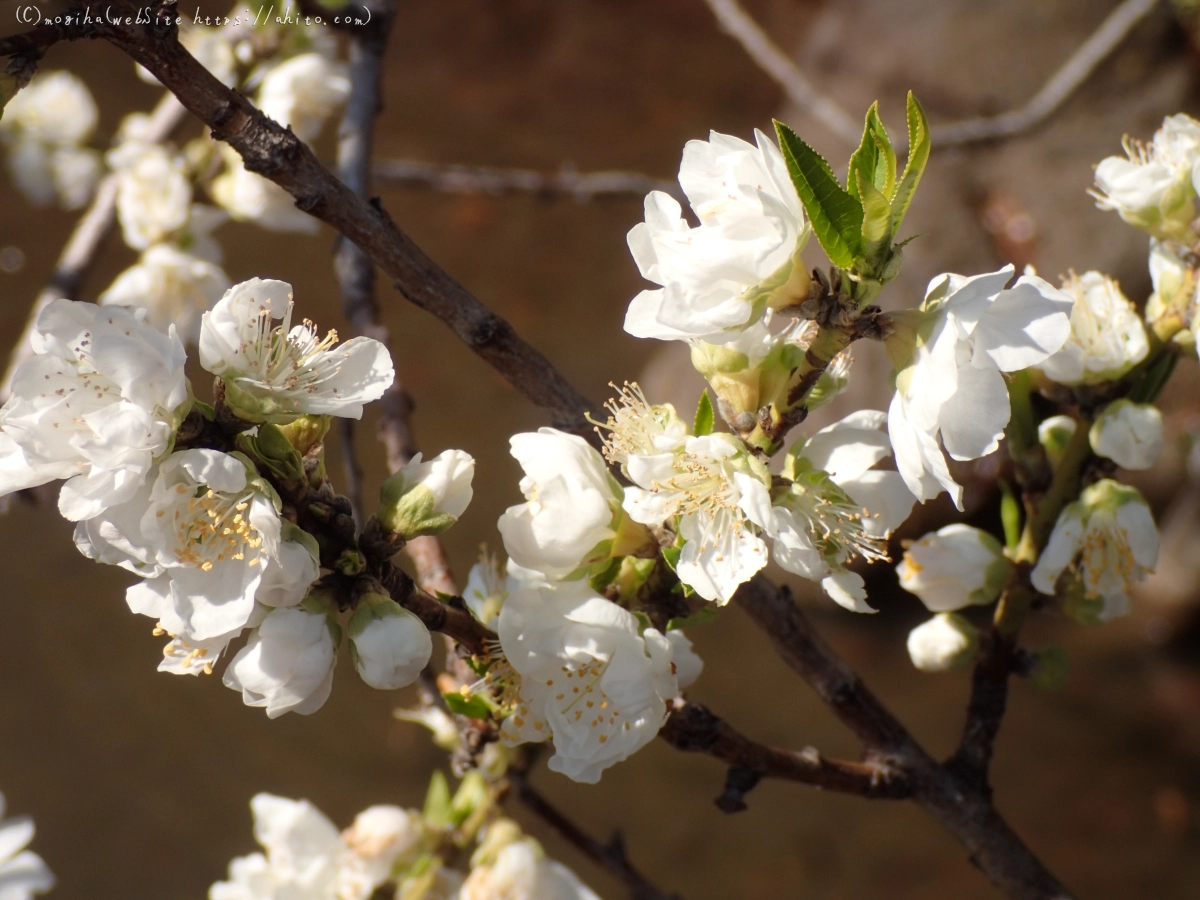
[659,703,913,812]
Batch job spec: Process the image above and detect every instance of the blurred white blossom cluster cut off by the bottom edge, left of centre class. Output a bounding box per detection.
[209,793,599,900]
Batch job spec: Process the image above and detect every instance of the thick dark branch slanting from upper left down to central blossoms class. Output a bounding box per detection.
[87,2,596,440]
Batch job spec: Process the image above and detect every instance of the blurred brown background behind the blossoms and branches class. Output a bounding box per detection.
[0,0,1200,900]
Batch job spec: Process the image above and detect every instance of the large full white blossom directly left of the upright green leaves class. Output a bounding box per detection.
[625,131,810,343]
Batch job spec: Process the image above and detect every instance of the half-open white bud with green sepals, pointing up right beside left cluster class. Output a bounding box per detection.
[378,450,475,540]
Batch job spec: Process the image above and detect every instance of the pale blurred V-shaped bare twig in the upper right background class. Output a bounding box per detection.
[704,0,1158,150]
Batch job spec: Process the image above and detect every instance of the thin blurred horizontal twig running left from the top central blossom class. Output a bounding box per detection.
[371,160,683,203]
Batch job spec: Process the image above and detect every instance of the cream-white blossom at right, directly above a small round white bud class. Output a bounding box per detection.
[1038,272,1150,385]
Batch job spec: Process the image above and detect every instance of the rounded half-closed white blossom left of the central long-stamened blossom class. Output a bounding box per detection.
[497,428,620,577]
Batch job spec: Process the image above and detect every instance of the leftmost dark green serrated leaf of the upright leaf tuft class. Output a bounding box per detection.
[775,121,863,269]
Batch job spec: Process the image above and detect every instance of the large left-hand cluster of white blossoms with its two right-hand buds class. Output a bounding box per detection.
[0,278,474,718]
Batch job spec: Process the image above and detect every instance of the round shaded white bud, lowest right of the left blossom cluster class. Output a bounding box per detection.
[348,594,433,691]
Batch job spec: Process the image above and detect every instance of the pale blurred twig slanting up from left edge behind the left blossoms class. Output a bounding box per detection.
[0,92,187,403]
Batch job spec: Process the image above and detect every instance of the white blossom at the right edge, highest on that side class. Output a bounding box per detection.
[1093,114,1200,244]
